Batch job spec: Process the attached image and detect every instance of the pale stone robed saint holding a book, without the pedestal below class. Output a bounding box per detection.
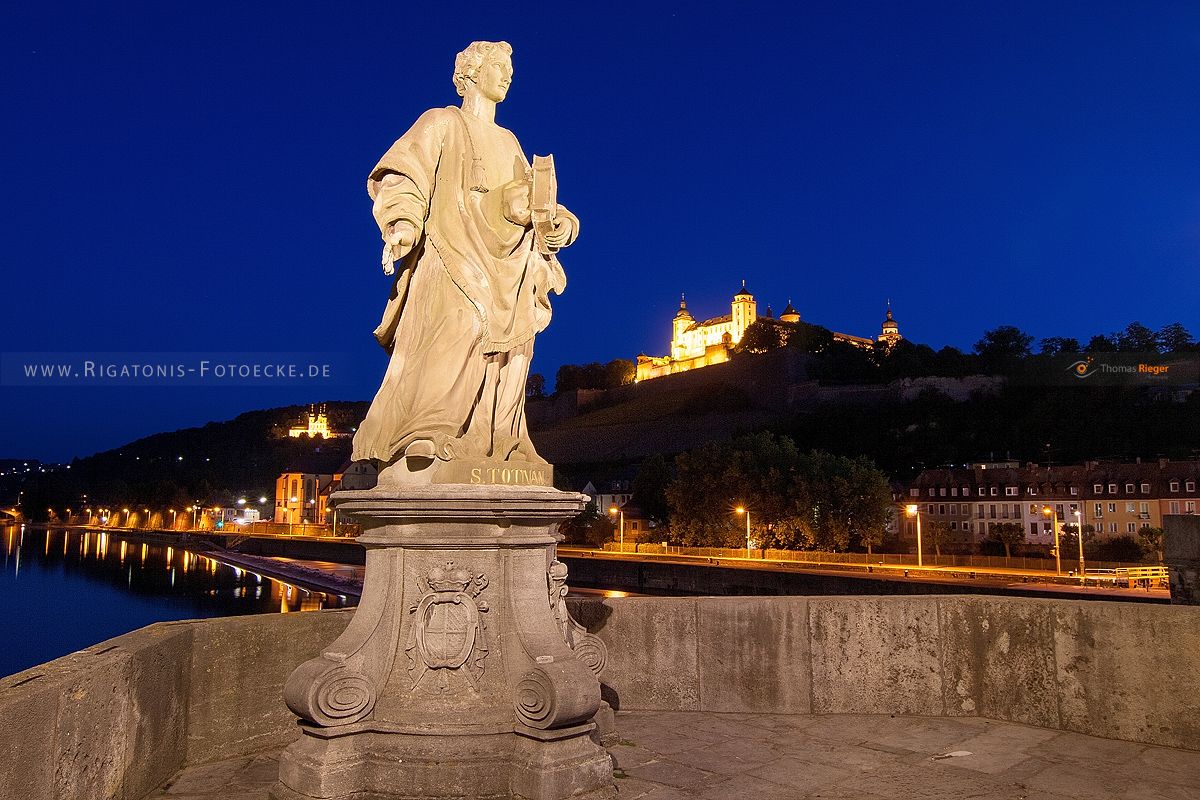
[353,42,580,485]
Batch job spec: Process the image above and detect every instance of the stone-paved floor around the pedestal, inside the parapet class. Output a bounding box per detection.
[148,711,1200,800]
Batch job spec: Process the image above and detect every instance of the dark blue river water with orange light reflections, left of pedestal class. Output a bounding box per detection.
[0,525,348,675]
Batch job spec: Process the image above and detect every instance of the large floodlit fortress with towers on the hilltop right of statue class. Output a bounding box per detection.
[636,281,904,380]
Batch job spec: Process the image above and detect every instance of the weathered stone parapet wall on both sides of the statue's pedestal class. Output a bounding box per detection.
[0,595,1200,800]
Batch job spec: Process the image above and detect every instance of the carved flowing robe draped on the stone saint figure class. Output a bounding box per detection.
[353,107,578,462]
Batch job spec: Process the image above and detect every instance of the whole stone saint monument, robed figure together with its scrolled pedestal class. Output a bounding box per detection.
[270,42,617,800]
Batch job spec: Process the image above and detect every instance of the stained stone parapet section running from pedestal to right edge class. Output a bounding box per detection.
[572,595,1200,750]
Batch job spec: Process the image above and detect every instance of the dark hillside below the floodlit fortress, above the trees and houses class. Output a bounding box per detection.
[530,349,1200,477]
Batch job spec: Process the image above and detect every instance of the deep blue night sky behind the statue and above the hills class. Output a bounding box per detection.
[0,0,1200,459]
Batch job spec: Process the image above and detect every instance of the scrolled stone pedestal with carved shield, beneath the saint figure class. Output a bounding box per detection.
[271,485,616,800]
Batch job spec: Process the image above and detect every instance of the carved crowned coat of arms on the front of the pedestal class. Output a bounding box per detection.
[404,561,487,692]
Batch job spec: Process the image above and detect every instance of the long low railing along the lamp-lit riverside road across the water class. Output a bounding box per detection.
[604,542,1137,572]
